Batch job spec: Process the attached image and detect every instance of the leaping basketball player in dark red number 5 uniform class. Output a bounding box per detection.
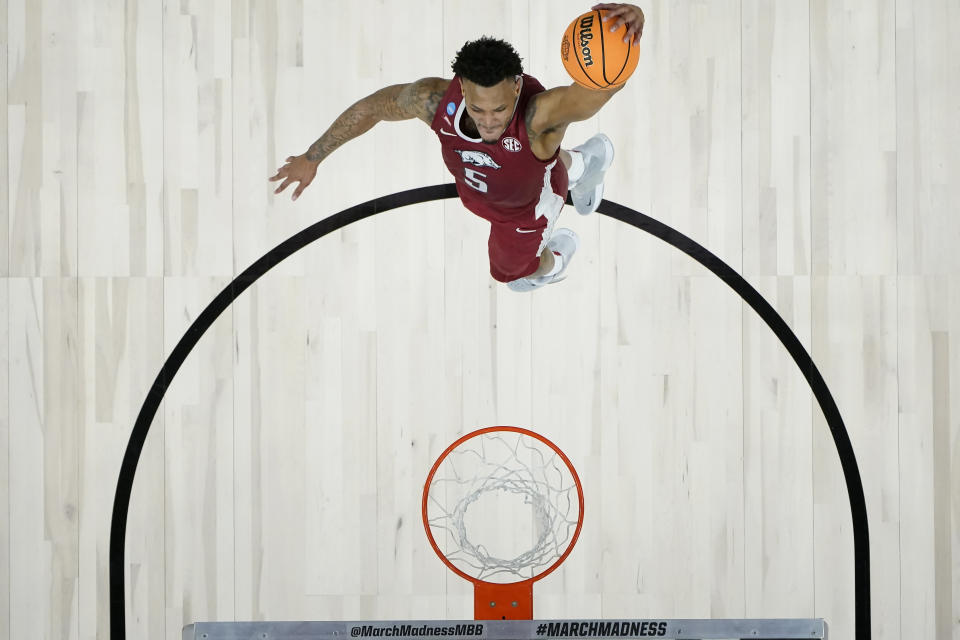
[270,3,644,291]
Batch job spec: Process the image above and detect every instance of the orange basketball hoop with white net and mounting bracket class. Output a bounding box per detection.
[422,427,583,620]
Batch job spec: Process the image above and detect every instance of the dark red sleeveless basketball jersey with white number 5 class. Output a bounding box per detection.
[431,74,567,226]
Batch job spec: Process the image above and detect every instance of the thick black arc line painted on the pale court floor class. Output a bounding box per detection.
[109,184,871,640]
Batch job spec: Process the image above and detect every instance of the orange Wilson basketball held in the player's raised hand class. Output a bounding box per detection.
[560,9,640,89]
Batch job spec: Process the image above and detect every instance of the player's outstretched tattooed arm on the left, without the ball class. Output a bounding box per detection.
[270,78,450,200]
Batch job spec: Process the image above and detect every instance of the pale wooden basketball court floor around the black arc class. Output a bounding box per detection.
[0,0,960,640]
